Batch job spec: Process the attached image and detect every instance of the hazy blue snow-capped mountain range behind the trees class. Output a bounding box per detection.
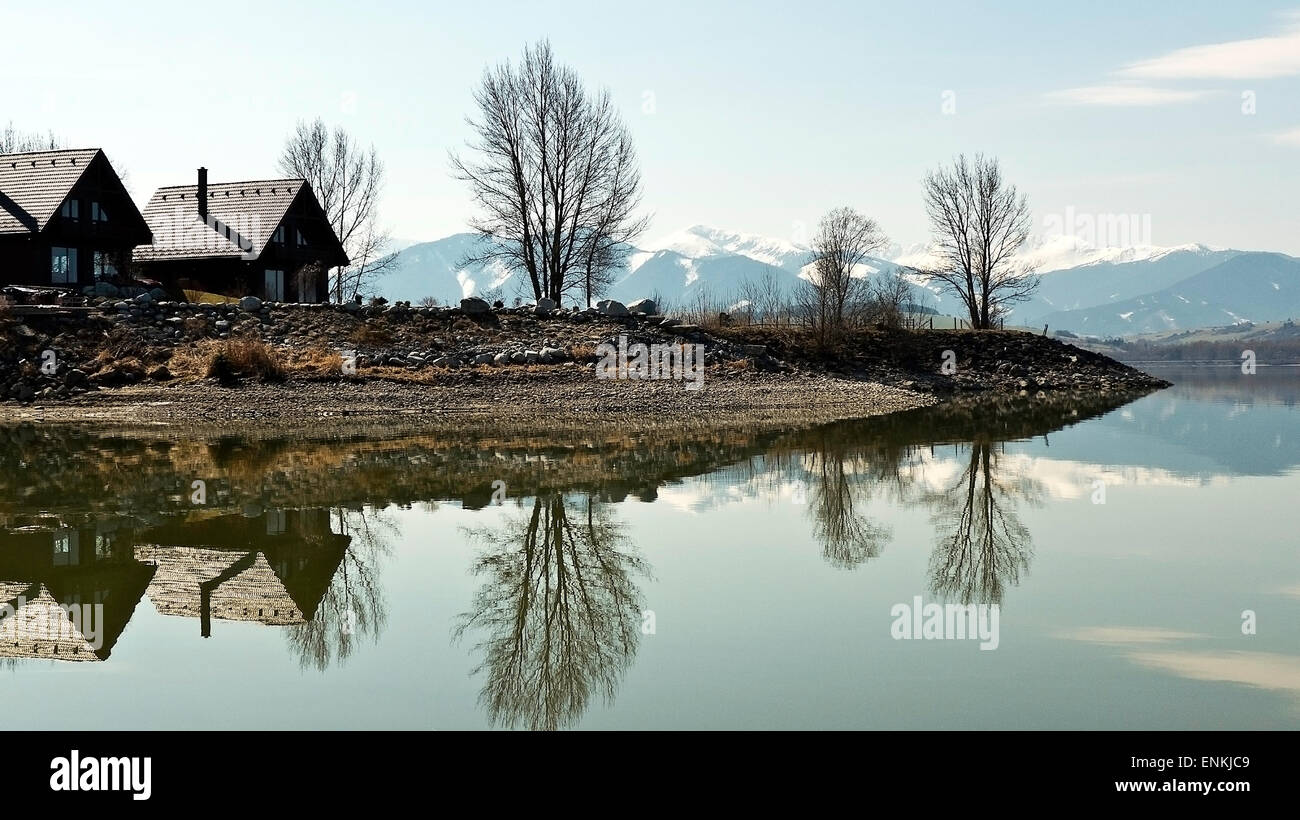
[380,225,1300,337]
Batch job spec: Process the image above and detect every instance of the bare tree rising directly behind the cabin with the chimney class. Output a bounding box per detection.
[278,118,398,301]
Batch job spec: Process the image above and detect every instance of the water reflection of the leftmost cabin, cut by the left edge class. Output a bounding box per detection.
[0,517,153,660]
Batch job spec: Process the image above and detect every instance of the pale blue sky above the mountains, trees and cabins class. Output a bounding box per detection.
[0,0,1300,255]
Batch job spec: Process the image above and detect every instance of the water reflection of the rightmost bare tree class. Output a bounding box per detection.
[926,437,1041,604]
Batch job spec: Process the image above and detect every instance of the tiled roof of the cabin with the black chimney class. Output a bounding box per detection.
[135,179,307,261]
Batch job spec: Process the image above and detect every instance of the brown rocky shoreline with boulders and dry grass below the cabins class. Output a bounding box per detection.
[0,292,1166,422]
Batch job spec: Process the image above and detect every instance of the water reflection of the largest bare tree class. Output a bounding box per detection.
[455,493,649,729]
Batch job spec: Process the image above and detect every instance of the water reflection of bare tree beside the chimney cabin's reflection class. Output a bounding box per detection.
[286,509,387,671]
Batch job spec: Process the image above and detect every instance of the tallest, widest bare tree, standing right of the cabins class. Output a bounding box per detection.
[451,42,646,301]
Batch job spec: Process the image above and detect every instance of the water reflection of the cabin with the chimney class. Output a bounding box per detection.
[135,509,351,635]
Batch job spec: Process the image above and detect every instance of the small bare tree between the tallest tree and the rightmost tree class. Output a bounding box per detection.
[800,208,889,338]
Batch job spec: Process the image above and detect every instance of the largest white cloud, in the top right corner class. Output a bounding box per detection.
[1119,12,1300,79]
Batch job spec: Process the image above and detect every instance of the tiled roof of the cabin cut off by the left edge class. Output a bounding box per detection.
[0,148,100,234]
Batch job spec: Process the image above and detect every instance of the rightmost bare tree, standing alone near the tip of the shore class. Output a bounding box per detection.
[920,153,1039,329]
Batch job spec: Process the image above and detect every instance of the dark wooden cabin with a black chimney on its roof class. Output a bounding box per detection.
[134,168,348,301]
